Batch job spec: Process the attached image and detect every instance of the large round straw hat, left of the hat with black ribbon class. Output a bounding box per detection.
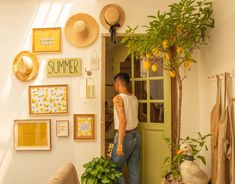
[64,13,99,47]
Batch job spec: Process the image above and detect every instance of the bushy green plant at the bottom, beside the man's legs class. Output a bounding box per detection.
[81,157,122,184]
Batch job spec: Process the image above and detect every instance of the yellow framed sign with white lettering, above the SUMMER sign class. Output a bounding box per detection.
[32,27,61,52]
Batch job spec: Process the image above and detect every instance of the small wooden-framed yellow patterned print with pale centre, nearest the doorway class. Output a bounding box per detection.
[74,114,95,139]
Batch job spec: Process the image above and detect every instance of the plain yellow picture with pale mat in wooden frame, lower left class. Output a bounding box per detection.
[14,119,51,150]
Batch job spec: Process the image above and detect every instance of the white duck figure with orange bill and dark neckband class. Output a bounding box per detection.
[177,143,209,184]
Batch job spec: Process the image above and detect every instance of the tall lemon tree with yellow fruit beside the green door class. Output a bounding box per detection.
[122,0,214,151]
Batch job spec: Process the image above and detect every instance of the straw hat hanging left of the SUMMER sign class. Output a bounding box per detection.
[13,51,39,81]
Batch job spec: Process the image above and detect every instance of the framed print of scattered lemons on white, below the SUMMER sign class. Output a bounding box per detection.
[29,84,69,115]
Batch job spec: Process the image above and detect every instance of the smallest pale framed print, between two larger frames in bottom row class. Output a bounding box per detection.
[56,120,69,137]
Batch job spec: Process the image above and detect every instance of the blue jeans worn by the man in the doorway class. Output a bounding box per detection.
[111,130,140,184]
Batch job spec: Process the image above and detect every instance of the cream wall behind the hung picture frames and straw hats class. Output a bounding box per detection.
[0,0,187,184]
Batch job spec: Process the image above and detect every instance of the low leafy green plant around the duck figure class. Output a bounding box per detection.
[162,132,211,182]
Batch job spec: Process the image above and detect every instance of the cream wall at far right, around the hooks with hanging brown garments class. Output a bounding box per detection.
[198,0,235,176]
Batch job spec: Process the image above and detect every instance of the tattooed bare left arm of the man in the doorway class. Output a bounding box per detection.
[113,96,126,156]
